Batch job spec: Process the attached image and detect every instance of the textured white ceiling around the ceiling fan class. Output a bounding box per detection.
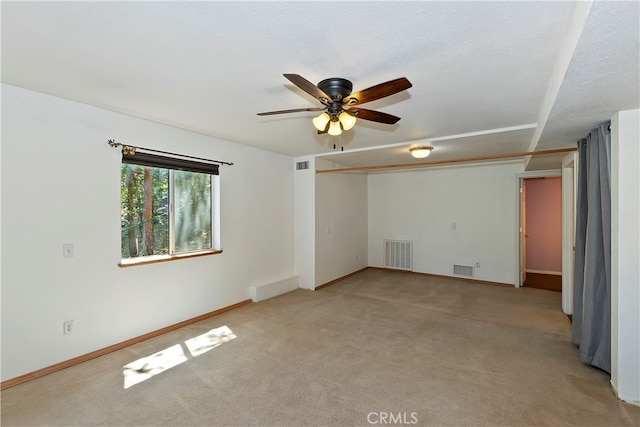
[1,1,640,168]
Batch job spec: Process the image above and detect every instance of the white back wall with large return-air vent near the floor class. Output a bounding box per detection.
[368,162,524,284]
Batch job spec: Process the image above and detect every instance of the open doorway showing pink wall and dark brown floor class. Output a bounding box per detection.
[522,176,562,292]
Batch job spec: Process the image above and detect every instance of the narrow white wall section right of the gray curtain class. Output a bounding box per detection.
[611,110,640,405]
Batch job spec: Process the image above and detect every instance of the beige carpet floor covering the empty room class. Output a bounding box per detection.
[1,269,640,426]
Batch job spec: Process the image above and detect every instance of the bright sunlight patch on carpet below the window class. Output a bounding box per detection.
[122,326,237,389]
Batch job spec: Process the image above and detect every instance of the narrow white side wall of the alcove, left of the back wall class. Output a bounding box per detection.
[315,159,367,286]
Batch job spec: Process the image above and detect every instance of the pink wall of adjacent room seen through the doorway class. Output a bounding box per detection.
[525,177,562,273]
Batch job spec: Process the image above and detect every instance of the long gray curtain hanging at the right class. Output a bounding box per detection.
[572,123,611,373]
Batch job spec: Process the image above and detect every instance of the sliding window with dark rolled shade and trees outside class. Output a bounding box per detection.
[120,151,219,264]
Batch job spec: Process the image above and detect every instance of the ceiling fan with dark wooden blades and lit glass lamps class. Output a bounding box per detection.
[258,74,412,136]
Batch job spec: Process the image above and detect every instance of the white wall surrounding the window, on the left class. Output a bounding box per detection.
[1,85,294,380]
